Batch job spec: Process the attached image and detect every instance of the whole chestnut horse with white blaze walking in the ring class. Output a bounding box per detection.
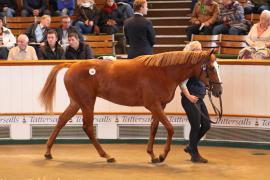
[40,51,222,163]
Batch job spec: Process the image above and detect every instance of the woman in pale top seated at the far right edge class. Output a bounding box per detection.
[239,10,270,59]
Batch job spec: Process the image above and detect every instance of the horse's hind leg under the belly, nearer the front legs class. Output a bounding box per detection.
[81,99,115,162]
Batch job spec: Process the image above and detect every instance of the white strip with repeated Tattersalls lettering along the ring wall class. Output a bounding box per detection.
[0,114,270,129]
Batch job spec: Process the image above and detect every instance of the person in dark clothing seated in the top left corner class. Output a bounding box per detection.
[0,0,18,17]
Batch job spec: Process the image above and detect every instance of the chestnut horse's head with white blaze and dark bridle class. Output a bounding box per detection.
[199,50,222,97]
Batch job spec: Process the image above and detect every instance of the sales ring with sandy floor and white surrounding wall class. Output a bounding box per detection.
[0,60,270,180]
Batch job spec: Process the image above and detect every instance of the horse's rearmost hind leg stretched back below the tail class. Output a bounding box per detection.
[44,102,80,159]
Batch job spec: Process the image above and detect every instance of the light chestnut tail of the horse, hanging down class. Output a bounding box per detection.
[39,63,72,112]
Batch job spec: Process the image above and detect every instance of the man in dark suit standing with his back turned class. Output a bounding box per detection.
[124,0,155,59]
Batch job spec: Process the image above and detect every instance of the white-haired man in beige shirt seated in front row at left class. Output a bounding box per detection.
[8,34,38,60]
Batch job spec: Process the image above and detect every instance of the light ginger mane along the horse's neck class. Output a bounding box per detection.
[134,51,209,67]
